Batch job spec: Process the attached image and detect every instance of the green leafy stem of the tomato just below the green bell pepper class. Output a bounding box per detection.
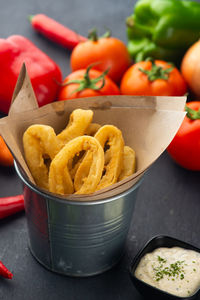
[139,58,174,81]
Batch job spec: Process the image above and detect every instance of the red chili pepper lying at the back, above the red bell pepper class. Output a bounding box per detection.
[30,14,87,50]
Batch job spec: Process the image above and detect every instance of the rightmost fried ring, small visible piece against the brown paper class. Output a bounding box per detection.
[118,146,135,181]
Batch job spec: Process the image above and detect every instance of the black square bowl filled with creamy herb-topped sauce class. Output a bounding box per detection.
[130,236,200,299]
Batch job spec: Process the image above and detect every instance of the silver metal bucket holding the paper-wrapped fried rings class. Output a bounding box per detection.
[15,164,141,276]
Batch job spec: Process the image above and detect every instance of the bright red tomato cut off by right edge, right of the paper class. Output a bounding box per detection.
[167,101,200,171]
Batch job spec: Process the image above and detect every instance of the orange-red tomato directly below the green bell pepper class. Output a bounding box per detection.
[120,60,187,96]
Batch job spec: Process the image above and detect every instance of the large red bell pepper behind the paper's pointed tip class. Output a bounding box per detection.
[0,35,62,114]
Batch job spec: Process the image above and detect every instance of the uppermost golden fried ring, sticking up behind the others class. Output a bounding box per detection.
[57,109,93,145]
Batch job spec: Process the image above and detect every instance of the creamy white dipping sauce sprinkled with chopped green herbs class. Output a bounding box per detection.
[135,247,200,297]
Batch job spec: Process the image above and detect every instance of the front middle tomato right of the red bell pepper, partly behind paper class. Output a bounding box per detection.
[58,69,120,100]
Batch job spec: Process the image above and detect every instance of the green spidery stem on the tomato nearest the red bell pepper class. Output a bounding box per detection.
[62,63,109,94]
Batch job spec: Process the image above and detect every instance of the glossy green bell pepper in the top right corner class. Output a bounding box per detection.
[126,0,200,65]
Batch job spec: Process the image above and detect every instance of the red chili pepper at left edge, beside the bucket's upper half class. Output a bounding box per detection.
[0,195,24,219]
